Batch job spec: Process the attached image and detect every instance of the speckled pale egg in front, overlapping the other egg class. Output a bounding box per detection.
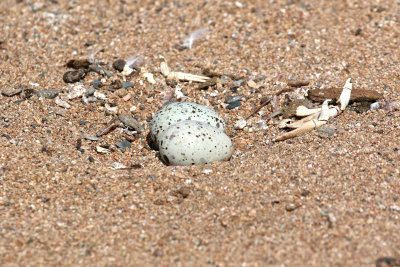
[159,120,233,165]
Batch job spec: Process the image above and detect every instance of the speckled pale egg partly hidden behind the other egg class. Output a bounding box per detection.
[150,102,225,145]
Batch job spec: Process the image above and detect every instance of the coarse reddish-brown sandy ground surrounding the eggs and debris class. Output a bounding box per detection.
[0,0,400,266]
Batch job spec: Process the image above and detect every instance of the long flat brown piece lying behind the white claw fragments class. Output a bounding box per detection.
[308,88,383,103]
